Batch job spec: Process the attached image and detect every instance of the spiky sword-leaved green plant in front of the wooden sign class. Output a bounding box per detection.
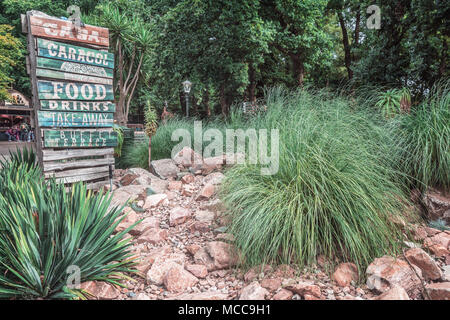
[0,151,137,299]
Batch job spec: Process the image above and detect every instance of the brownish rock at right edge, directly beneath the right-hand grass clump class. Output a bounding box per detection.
[422,188,450,224]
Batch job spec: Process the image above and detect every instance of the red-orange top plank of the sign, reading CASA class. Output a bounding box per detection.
[30,16,109,47]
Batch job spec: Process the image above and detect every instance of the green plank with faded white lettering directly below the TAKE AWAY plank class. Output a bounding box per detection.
[44,130,117,148]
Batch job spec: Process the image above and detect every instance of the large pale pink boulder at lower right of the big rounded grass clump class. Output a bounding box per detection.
[366,256,422,299]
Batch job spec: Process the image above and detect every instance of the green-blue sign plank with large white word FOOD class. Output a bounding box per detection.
[38,80,114,100]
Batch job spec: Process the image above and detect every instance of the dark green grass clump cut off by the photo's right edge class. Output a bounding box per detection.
[394,82,450,189]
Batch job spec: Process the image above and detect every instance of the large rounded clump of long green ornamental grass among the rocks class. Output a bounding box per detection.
[221,89,414,270]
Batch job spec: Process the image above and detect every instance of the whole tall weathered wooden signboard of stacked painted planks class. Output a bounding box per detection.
[22,11,117,189]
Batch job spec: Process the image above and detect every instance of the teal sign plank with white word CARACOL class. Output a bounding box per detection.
[37,38,114,69]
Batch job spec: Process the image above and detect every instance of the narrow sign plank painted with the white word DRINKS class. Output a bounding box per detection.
[41,100,116,112]
